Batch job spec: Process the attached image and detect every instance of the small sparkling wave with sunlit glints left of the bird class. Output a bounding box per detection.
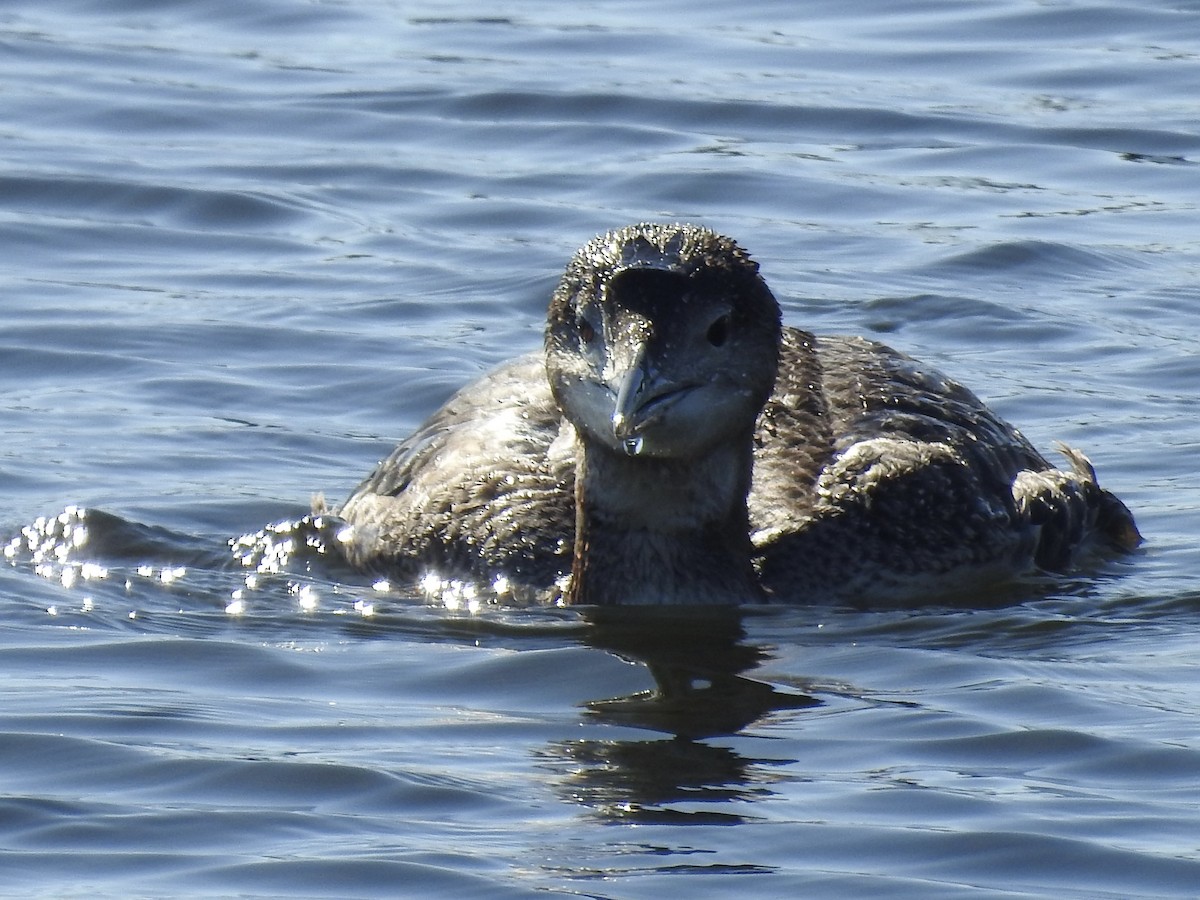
[0,506,581,642]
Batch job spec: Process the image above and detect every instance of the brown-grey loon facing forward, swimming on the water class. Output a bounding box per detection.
[336,224,1140,606]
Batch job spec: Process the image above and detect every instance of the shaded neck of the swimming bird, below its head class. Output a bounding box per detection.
[566,433,764,606]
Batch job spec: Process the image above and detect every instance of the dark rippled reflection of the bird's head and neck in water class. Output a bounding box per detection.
[544,608,820,824]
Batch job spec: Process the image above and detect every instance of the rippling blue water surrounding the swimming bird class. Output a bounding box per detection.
[0,0,1200,899]
